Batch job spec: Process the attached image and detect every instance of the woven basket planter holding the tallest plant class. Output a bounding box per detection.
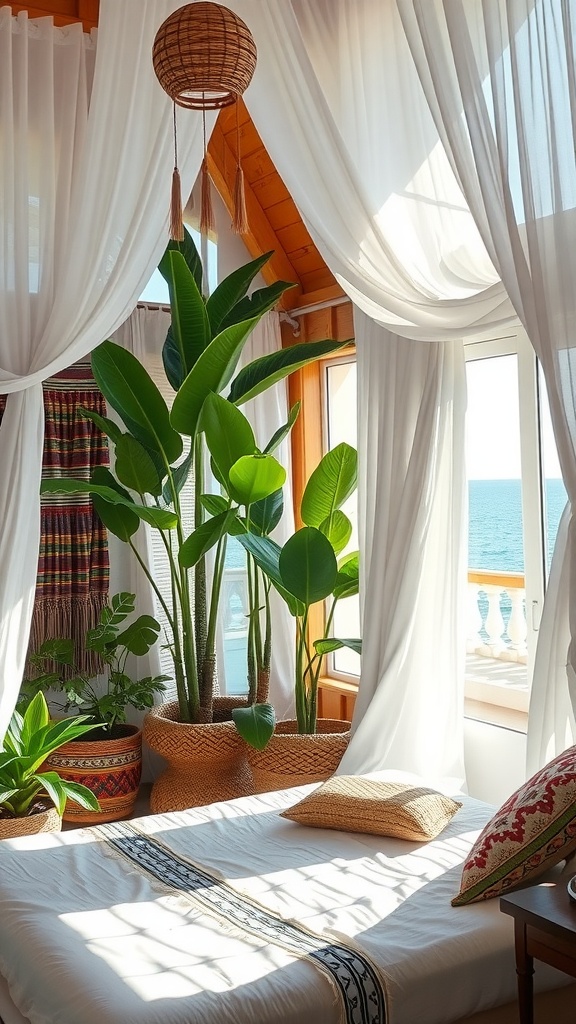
[143,700,253,814]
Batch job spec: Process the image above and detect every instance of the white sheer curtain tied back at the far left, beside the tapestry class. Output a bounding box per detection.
[0,0,207,737]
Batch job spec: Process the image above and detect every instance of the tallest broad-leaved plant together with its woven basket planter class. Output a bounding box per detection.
[42,234,341,811]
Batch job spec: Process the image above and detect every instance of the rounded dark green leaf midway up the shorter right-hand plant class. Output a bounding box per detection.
[279,526,338,606]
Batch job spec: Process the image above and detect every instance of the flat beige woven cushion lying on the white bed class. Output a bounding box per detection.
[281,775,462,843]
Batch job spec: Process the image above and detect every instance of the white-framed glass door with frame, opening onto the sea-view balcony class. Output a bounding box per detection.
[465,332,566,717]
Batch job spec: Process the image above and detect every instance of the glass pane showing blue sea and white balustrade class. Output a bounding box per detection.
[466,354,527,707]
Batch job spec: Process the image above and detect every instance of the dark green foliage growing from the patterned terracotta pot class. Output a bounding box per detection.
[20,592,169,734]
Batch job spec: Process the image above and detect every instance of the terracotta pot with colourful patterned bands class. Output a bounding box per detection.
[45,725,142,824]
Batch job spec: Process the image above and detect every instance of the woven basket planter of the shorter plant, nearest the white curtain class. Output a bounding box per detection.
[247,718,351,793]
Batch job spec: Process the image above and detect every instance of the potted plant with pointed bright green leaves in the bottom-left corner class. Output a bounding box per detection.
[0,693,98,839]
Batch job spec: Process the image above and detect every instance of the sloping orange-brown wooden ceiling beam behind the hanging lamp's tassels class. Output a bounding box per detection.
[207,122,302,310]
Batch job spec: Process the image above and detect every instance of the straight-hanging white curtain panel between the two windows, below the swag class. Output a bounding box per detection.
[339,310,466,784]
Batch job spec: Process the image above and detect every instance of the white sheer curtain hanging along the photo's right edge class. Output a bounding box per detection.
[398,0,576,771]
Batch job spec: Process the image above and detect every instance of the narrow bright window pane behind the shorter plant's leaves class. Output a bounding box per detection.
[325,361,360,676]
